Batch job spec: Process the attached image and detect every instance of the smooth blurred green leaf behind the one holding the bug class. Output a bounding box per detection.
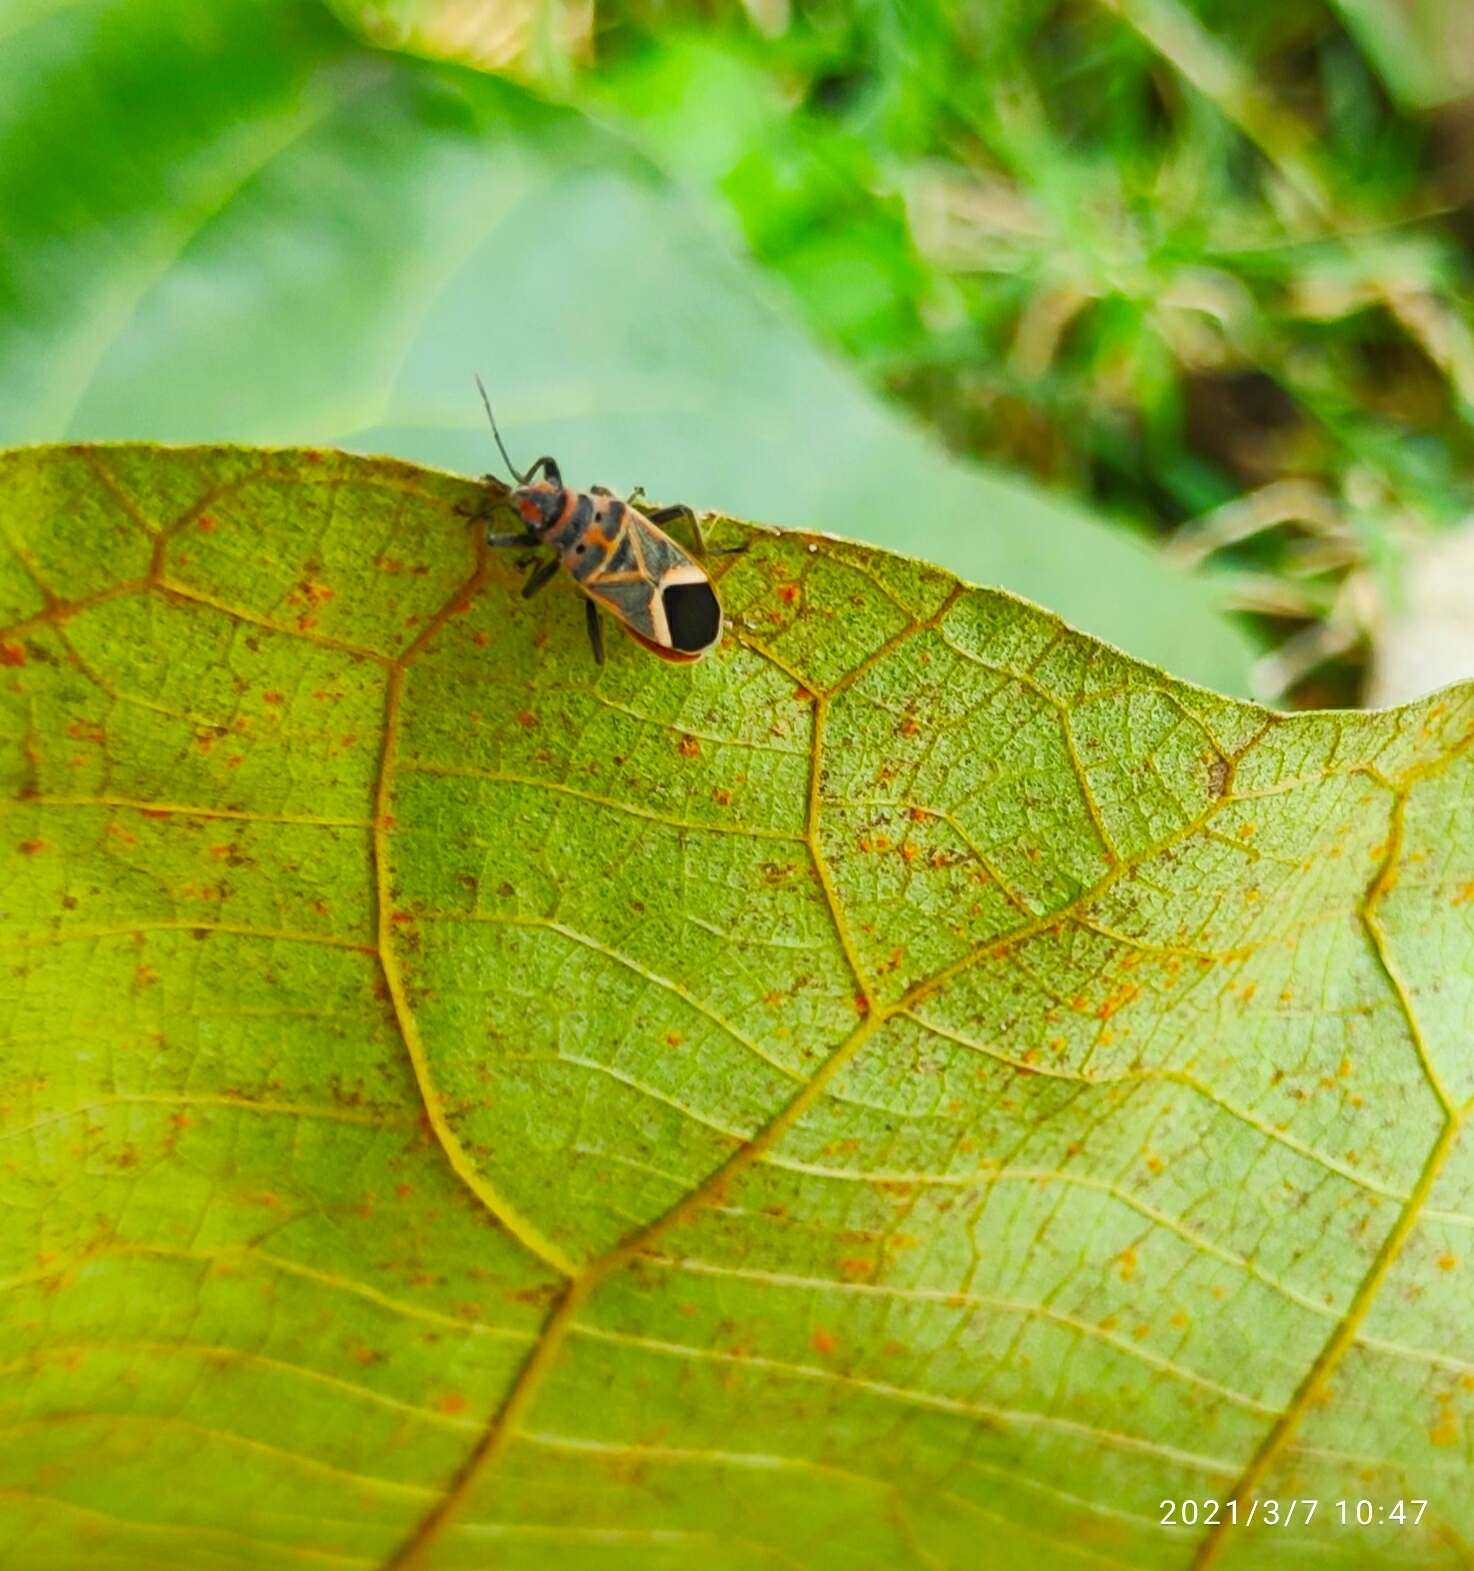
[0,0,1254,691]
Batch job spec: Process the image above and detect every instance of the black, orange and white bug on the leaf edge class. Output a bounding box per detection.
[476,377,729,665]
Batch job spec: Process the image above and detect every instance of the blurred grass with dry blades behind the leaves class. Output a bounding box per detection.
[330,0,1474,704]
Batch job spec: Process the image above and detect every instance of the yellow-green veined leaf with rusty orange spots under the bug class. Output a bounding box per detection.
[0,446,1474,1571]
